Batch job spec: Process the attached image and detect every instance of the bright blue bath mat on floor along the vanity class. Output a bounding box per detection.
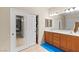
[41,42,63,52]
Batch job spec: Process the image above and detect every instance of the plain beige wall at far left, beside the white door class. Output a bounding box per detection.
[0,8,10,51]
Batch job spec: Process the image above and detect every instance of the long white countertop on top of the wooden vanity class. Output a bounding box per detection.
[45,30,79,36]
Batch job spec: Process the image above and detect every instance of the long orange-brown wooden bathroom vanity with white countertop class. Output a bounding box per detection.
[44,30,79,52]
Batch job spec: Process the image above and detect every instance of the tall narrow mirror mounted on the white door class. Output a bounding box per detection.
[16,15,24,47]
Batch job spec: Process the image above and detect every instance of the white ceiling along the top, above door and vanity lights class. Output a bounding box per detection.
[17,7,70,14]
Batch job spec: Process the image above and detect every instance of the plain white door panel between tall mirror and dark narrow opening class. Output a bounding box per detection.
[26,15,36,47]
